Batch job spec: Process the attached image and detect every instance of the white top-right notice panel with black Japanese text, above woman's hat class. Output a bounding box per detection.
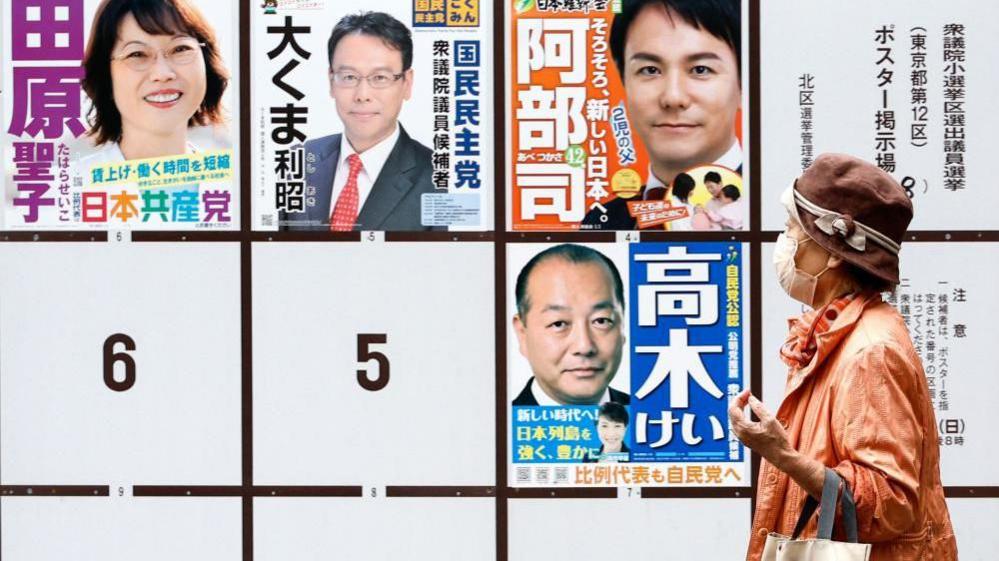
[760,0,999,230]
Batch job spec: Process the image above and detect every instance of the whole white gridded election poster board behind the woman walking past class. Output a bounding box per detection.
[0,0,999,561]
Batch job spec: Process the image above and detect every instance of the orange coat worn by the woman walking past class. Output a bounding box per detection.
[746,294,957,561]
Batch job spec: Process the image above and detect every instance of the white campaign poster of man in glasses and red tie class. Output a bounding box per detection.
[250,0,493,231]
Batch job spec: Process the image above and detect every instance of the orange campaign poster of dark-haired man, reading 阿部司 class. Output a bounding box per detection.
[506,0,749,231]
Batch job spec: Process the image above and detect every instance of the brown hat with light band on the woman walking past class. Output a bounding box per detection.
[781,154,912,284]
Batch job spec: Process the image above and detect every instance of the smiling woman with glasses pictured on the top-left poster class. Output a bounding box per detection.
[81,0,229,162]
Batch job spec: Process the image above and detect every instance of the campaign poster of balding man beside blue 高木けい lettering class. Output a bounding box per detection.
[508,242,750,487]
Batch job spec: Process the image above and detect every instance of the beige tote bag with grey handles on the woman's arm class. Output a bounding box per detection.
[761,468,871,561]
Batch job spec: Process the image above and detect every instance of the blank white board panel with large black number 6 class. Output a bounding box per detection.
[0,243,240,485]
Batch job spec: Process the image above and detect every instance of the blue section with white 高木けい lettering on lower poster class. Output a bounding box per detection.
[629,242,744,462]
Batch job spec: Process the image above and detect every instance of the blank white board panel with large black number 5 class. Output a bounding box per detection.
[253,243,495,485]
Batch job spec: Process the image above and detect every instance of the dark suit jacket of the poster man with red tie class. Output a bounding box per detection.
[281,125,446,230]
